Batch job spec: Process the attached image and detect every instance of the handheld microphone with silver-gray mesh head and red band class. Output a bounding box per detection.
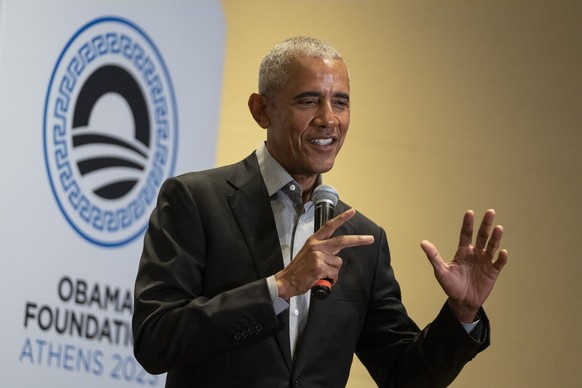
[311,185,339,300]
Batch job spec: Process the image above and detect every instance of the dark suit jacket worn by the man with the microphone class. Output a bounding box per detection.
[133,153,489,388]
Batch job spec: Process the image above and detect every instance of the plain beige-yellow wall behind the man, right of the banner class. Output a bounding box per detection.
[217,0,582,387]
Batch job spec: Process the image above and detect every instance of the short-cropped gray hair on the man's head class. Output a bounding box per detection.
[259,36,350,99]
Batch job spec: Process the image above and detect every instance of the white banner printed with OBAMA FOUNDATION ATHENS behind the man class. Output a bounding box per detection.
[0,0,226,388]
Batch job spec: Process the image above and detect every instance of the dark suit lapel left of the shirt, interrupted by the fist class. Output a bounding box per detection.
[228,154,292,370]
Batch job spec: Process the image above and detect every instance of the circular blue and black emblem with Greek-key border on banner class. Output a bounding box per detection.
[43,17,178,246]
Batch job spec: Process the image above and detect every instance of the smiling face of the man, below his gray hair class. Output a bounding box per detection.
[267,58,350,183]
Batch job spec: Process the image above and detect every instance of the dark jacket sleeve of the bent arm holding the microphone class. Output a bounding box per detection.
[132,178,280,373]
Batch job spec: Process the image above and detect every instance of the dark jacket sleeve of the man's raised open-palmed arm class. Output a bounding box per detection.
[356,226,489,387]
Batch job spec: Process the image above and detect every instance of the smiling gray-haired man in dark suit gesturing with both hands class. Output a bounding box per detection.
[133,38,507,387]
